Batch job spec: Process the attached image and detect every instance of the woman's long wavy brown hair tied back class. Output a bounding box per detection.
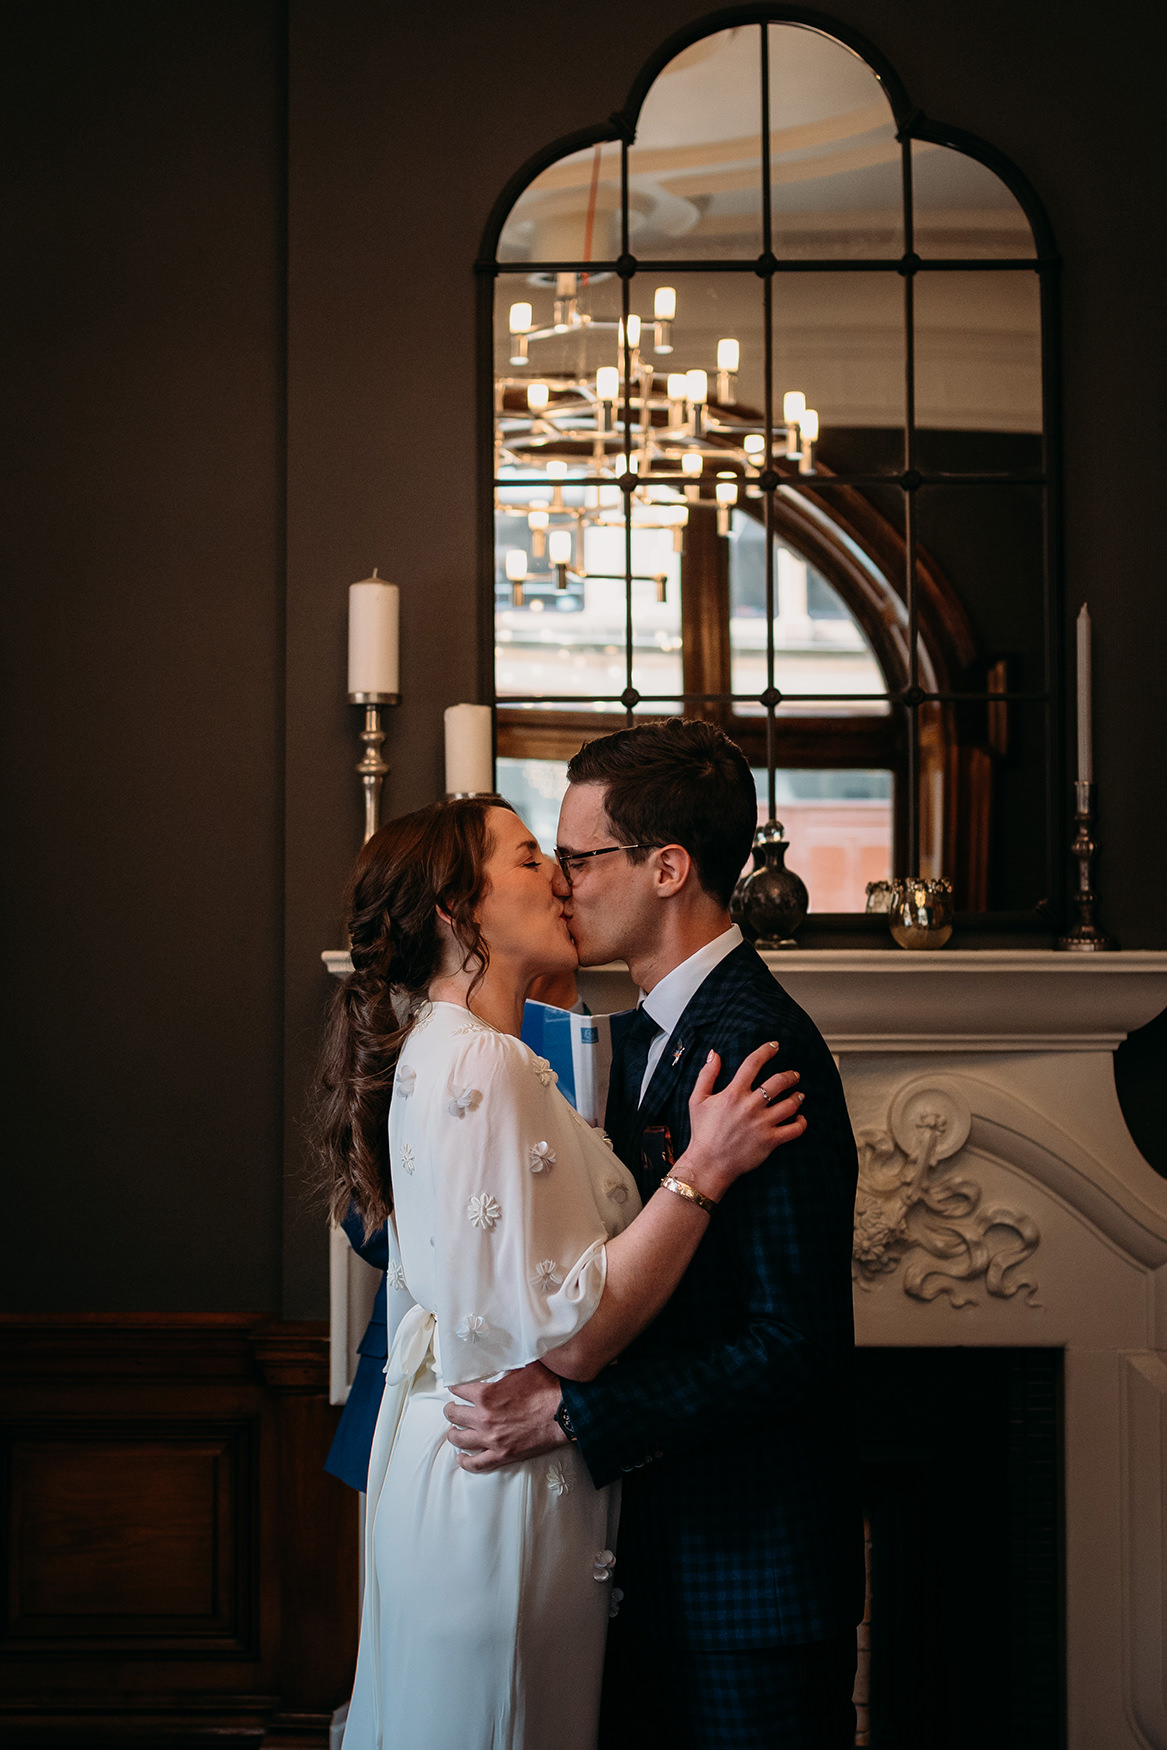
[313,798,499,1234]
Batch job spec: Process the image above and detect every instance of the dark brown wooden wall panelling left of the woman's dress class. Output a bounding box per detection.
[0,1314,359,1750]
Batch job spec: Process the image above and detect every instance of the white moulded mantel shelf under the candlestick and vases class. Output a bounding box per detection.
[320,949,1167,1052]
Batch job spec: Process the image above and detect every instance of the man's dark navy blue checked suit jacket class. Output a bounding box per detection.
[563,943,863,1650]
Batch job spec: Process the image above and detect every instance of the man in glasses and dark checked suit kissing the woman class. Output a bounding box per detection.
[446,719,863,1750]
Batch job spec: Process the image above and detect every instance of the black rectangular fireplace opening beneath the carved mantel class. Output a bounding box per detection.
[856,1348,1066,1750]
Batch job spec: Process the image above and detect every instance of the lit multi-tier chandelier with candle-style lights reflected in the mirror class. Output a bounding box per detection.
[495,273,819,607]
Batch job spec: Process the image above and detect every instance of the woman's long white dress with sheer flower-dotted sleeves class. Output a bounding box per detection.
[345,1003,640,1750]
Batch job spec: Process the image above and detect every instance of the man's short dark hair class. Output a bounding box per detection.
[567,718,758,905]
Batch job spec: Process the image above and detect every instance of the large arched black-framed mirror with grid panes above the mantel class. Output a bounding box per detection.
[479,7,1060,919]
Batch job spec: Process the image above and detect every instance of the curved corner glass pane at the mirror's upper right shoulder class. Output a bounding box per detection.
[912,140,1036,261]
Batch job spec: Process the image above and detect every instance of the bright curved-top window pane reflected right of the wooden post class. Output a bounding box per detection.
[730,513,891,710]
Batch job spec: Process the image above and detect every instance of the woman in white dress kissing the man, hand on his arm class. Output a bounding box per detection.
[320,800,805,1750]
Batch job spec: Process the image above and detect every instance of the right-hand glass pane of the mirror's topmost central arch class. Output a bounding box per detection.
[768,25,903,259]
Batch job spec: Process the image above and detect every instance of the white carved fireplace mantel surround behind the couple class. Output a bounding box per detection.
[327,949,1167,1750]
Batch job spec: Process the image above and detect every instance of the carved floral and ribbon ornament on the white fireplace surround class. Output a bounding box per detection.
[852,1082,1041,1307]
